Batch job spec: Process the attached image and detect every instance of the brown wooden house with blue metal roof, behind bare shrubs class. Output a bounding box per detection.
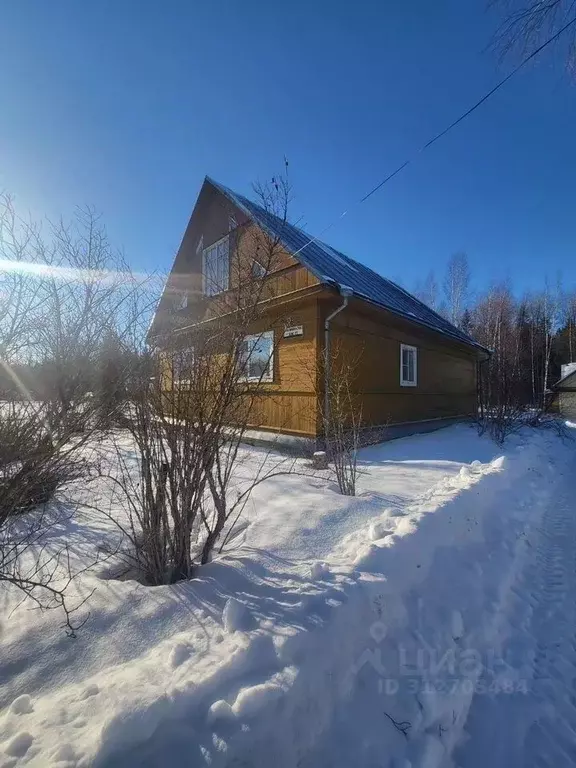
[149,177,489,444]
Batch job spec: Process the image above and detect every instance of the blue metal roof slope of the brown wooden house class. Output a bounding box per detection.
[206,176,488,351]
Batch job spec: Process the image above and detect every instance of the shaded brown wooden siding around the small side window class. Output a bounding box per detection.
[321,300,477,426]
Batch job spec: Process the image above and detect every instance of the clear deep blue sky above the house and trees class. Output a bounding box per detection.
[0,0,576,291]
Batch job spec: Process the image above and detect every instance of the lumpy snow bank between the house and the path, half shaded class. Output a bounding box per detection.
[0,429,564,768]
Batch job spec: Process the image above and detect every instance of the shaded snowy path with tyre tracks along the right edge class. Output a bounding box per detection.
[454,465,576,768]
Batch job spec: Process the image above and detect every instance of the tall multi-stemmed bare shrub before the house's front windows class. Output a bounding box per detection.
[95,171,302,584]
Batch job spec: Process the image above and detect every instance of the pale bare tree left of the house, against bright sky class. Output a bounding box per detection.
[36,208,158,431]
